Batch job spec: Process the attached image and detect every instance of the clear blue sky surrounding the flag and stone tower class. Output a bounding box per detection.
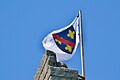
[0,0,120,80]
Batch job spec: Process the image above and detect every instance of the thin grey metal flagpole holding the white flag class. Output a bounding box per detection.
[79,11,85,78]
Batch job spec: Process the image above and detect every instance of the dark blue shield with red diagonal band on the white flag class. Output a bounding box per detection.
[52,25,76,54]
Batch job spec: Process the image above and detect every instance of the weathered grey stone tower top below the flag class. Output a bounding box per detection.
[34,50,84,80]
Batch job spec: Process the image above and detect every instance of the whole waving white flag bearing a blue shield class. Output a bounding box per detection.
[42,17,79,62]
